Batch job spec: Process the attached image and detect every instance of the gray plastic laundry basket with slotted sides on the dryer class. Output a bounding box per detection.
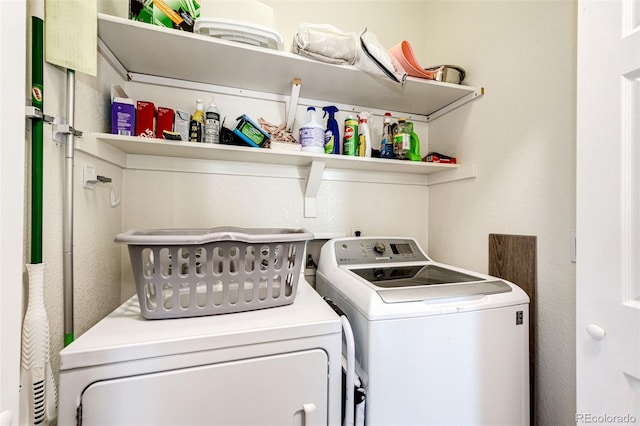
[115,227,313,319]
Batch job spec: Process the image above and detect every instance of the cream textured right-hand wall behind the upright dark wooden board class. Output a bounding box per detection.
[425,1,577,425]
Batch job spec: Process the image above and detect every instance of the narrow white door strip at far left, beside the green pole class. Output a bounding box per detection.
[0,1,27,426]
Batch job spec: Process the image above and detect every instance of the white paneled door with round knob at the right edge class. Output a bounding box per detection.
[567,0,640,424]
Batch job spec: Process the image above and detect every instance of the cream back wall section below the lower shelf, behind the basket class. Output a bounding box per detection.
[122,170,427,298]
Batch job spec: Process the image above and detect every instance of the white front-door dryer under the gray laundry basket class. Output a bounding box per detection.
[58,278,342,426]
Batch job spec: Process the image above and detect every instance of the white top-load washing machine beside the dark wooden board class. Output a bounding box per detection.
[316,237,529,426]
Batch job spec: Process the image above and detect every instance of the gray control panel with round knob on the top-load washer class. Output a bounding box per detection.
[334,237,429,265]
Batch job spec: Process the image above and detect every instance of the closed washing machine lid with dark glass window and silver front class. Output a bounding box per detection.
[348,264,511,303]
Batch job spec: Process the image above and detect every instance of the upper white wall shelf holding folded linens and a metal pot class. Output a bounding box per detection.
[98,14,483,120]
